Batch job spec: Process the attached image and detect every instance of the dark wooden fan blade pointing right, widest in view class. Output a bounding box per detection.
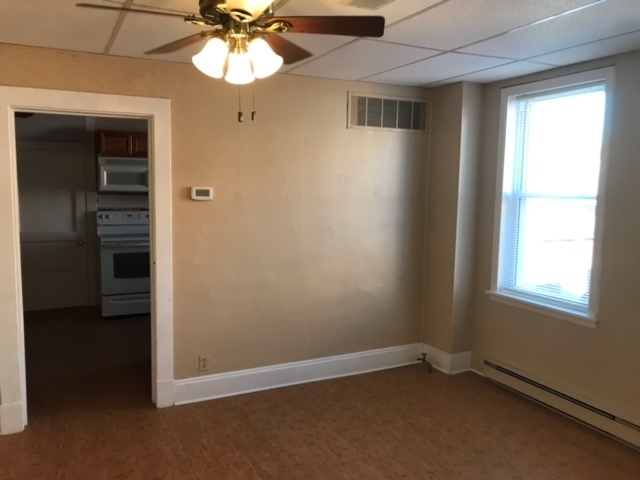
[266,16,384,37]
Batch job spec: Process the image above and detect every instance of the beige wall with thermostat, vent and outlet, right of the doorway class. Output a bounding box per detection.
[0,45,428,378]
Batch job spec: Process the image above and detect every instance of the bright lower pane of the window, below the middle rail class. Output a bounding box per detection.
[510,198,596,307]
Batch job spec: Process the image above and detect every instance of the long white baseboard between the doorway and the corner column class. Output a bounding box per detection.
[175,343,422,405]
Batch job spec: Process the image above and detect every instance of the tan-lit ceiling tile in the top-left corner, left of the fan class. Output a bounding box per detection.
[0,0,119,53]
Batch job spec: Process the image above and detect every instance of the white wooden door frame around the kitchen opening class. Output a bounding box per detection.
[0,86,174,434]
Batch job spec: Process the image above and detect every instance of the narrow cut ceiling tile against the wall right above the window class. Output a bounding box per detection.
[531,31,640,65]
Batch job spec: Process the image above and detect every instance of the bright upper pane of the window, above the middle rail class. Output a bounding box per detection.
[515,85,605,196]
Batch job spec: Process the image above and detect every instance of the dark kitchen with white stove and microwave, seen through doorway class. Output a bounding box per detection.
[16,113,151,404]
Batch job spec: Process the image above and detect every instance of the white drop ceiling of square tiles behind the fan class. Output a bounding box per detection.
[0,0,640,87]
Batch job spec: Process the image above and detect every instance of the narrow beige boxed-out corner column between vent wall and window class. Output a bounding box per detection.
[423,83,482,353]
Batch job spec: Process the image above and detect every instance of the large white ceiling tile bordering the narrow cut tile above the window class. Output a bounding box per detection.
[460,0,640,59]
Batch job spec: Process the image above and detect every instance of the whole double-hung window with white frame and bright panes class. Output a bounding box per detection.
[492,69,612,321]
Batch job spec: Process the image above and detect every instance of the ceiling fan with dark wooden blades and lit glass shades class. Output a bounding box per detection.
[76,0,385,84]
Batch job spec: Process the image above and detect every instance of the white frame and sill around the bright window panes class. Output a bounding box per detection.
[487,67,614,328]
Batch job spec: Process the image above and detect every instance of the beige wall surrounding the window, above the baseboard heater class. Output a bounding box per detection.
[473,52,640,423]
